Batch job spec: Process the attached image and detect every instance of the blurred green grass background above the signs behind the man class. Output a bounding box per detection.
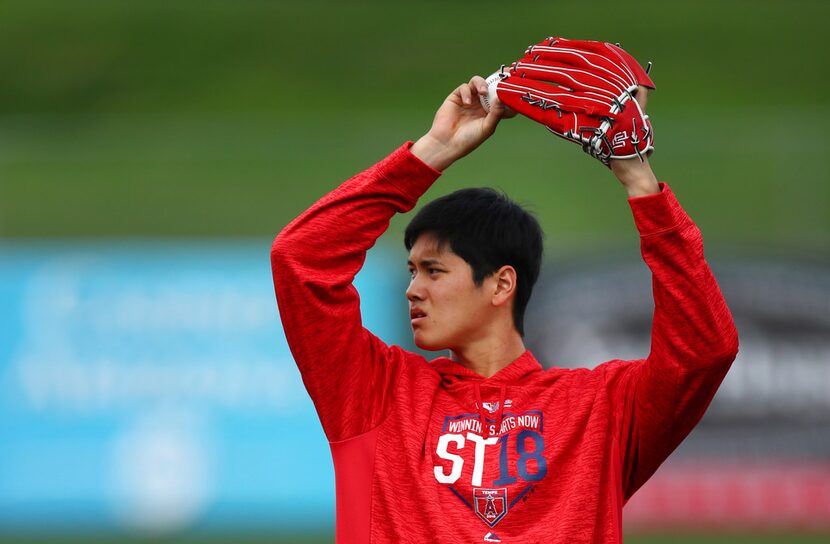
[0,0,830,543]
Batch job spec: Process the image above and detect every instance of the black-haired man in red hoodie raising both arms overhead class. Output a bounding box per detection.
[271,60,737,543]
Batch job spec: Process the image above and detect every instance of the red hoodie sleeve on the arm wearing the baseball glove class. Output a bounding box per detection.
[606,183,738,500]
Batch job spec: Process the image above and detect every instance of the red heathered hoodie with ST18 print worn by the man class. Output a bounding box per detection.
[271,143,738,544]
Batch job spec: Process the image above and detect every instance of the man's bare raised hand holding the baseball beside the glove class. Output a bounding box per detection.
[411,76,505,170]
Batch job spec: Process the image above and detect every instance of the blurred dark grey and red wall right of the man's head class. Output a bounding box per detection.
[527,253,830,531]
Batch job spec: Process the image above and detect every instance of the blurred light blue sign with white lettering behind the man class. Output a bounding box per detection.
[0,240,406,532]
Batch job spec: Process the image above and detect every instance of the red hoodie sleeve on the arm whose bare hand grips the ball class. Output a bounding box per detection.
[271,142,440,441]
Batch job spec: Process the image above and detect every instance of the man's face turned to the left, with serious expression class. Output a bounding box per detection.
[406,234,492,351]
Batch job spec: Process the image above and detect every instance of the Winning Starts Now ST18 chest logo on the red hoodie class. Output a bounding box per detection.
[433,410,548,527]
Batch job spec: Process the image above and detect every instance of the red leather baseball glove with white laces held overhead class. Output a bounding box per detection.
[482,38,654,166]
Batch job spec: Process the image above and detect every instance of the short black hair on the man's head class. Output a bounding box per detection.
[404,188,542,336]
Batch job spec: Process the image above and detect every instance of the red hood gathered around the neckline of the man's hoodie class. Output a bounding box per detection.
[432,351,542,436]
